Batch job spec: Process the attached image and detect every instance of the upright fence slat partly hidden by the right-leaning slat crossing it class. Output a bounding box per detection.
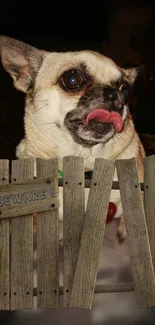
[63,156,85,307]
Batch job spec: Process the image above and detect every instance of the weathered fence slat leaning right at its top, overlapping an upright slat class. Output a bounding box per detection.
[69,159,114,309]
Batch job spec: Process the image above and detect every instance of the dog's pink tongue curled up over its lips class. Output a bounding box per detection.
[84,109,123,132]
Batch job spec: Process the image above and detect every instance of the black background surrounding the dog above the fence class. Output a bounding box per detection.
[0,0,155,159]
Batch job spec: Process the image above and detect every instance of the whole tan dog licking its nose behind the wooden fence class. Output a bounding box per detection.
[0,36,144,239]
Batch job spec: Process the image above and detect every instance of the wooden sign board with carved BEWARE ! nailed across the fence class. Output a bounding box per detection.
[0,178,59,219]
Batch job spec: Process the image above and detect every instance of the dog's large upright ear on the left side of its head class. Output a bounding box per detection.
[0,36,45,93]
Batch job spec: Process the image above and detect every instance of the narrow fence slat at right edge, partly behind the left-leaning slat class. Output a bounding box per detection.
[144,155,155,270]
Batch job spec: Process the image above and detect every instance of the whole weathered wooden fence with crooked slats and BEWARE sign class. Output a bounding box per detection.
[0,156,155,310]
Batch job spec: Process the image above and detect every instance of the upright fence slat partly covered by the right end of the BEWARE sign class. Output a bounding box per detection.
[37,159,59,308]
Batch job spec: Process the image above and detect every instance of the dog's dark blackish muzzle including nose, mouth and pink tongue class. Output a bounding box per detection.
[65,86,127,144]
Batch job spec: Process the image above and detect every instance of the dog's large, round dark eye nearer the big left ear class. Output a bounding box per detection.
[61,70,86,91]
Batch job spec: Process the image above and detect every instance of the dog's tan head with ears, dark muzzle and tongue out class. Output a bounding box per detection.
[0,37,143,147]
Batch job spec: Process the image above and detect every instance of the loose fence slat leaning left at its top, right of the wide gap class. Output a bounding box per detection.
[116,158,155,308]
